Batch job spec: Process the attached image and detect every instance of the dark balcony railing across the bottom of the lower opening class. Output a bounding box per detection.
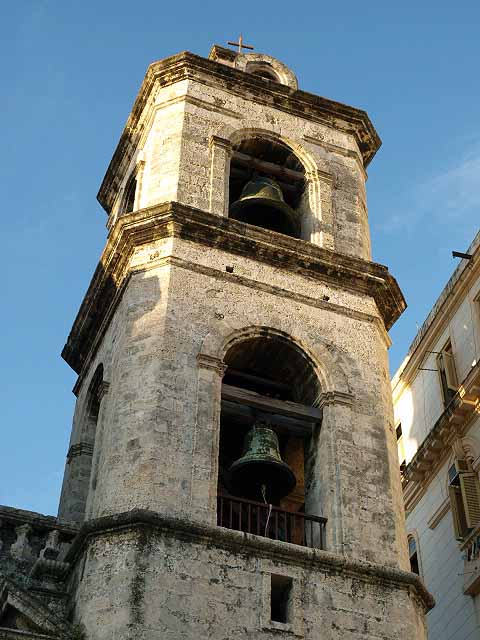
[217,495,327,549]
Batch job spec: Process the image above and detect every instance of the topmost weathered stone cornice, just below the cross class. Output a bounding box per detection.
[97,51,381,213]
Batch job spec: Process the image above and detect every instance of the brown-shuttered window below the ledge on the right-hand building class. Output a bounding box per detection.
[448,459,480,540]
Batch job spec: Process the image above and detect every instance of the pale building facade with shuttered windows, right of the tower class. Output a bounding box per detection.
[393,233,480,640]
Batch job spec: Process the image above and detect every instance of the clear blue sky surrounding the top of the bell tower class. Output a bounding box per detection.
[0,0,480,514]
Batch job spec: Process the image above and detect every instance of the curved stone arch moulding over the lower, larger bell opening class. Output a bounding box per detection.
[199,317,351,397]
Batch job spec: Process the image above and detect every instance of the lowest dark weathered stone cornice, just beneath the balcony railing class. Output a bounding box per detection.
[65,509,435,611]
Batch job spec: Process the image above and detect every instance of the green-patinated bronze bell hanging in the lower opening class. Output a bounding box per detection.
[230,422,296,502]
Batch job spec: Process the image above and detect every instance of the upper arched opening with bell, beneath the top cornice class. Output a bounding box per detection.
[229,136,305,238]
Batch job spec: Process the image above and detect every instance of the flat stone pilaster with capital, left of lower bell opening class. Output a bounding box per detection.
[190,354,227,525]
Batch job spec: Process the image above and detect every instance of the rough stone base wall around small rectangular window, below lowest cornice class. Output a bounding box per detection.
[68,528,425,640]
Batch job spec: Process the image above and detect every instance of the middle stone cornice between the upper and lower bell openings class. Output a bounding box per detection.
[62,202,406,373]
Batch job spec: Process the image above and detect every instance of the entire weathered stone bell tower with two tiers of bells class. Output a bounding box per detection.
[59,46,432,640]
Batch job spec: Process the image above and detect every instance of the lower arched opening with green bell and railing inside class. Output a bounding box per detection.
[218,330,324,546]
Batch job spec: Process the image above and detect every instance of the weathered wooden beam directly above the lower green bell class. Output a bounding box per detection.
[222,400,316,438]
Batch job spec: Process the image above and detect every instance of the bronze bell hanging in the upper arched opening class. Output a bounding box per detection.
[230,177,298,236]
